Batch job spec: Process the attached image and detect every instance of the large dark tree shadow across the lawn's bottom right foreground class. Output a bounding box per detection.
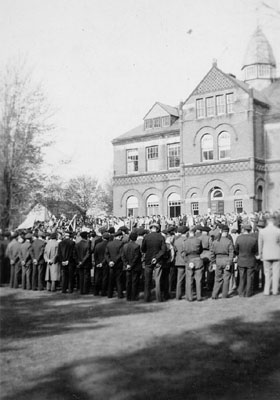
[2,311,280,400]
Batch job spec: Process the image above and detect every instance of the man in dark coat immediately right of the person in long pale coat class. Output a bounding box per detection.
[57,231,75,293]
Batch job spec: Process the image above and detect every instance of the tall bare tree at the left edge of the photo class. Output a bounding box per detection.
[0,59,52,229]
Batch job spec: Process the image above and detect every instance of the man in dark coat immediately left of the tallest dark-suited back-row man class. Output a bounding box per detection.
[122,232,142,301]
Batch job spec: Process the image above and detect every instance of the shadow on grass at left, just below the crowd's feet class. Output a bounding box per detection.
[0,289,161,340]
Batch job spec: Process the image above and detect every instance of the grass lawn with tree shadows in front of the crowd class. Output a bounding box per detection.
[0,287,280,400]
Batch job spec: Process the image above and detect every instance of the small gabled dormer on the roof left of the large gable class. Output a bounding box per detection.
[143,102,179,131]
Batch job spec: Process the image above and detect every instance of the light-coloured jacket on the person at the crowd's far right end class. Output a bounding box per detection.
[259,222,280,260]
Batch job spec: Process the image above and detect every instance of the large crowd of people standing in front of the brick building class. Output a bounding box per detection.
[0,212,280,302]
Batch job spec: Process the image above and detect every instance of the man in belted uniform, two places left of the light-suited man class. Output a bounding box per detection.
[210,224,234,300]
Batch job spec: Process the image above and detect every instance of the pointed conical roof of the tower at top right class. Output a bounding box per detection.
[242,27,276,69]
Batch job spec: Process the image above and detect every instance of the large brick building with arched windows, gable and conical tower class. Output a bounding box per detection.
[113,28,280,217]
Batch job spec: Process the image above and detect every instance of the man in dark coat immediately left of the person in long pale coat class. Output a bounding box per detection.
[31,231,46,290]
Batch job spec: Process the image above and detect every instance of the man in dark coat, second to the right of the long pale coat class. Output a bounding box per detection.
[74,231,92,294]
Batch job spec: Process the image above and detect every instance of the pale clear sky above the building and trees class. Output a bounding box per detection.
[0,0,280,182]
